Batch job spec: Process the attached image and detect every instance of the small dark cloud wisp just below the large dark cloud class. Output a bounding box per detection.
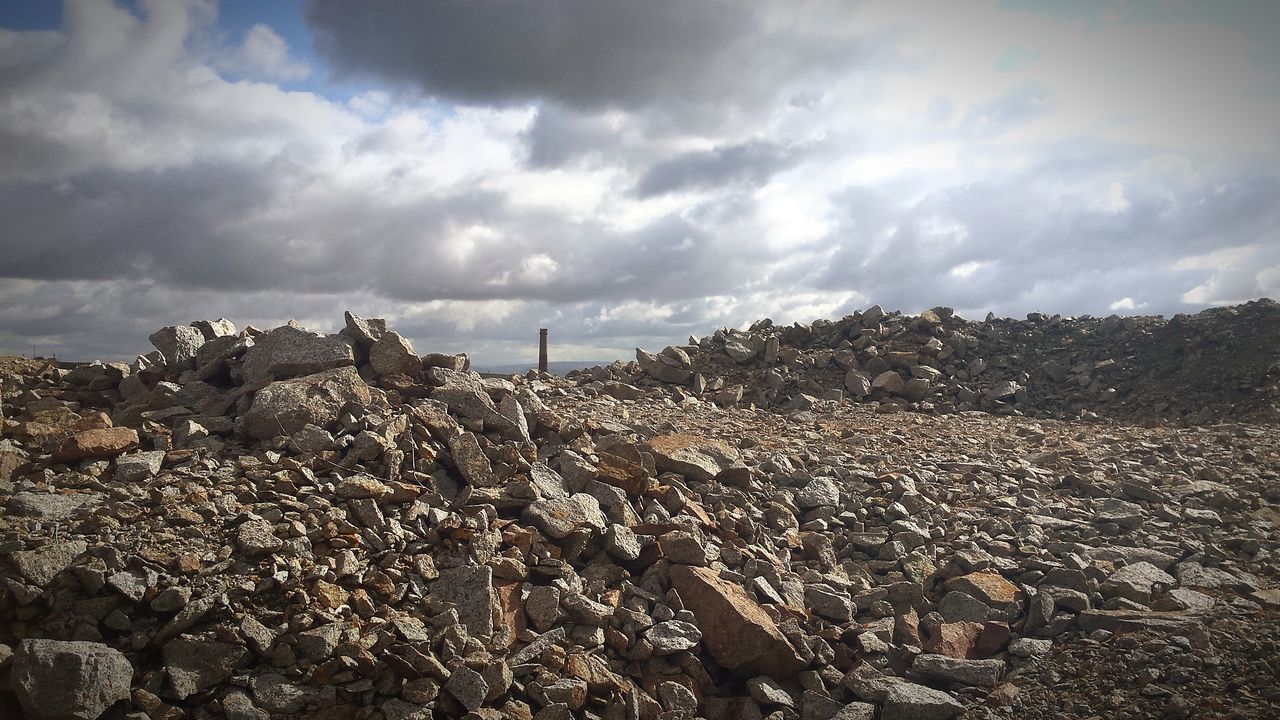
[636,141,799,197]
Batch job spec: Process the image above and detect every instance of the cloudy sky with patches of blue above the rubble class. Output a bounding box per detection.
[0,0,1280,364]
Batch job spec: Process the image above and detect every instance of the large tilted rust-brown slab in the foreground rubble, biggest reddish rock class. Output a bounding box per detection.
[671,565,805,679]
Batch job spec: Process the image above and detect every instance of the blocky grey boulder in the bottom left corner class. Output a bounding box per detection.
[9,639,133,720]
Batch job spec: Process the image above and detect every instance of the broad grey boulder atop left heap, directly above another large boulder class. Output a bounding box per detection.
[239,325,356,384]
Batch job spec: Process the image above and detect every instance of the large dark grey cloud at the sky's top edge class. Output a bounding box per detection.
[306,0,863,114]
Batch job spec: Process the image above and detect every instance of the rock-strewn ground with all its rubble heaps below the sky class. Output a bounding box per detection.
[0,302,1280,720]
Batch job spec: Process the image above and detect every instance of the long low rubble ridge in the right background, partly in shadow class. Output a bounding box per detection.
[571,300,1280,421]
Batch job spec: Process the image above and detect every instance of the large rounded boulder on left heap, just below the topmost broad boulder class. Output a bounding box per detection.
[237,366,371,439]
